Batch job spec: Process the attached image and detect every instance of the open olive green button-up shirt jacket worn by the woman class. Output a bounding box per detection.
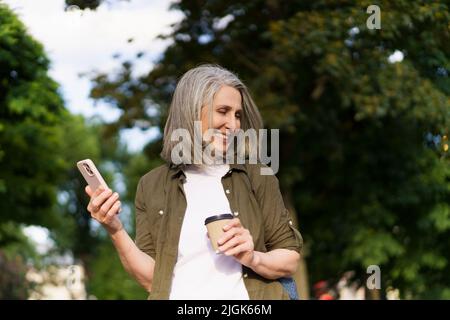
[135,164,303,300]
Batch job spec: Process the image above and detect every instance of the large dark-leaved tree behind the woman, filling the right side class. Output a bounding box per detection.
[91,0,450,298]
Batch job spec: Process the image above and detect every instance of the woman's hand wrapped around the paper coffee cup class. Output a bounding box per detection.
[218,218,255,267]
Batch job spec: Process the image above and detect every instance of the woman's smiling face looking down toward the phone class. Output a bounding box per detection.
[200,86,242,152]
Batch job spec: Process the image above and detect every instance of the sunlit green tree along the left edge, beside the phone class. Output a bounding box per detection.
[0,4,110,297]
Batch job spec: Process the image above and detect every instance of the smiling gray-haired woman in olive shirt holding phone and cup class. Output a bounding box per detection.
[86,65,302,300]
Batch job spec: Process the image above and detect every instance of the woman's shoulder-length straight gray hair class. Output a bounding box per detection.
[161,64,263,164]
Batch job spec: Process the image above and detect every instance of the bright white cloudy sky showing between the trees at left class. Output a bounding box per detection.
[0,0,181,253]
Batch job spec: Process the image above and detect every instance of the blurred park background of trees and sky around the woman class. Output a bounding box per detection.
[0,0,450,299]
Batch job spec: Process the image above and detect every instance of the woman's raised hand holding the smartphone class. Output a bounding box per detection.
[85,186,123,234]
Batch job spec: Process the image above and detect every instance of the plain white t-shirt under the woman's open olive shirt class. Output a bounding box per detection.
[169,165,249,300]
